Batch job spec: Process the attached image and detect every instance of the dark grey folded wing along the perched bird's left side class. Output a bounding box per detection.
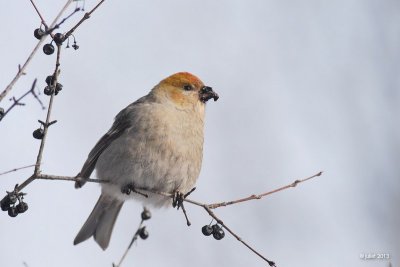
[75,106,131,188]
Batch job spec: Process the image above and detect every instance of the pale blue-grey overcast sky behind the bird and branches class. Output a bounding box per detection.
[0,0,400,267]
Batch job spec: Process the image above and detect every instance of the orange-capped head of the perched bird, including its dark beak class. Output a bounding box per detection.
[153,72,219,109]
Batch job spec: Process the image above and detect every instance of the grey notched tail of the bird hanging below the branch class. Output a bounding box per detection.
[74,195,124,250]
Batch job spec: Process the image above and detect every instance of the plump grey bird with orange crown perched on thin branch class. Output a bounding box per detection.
[74,72,219,250]
